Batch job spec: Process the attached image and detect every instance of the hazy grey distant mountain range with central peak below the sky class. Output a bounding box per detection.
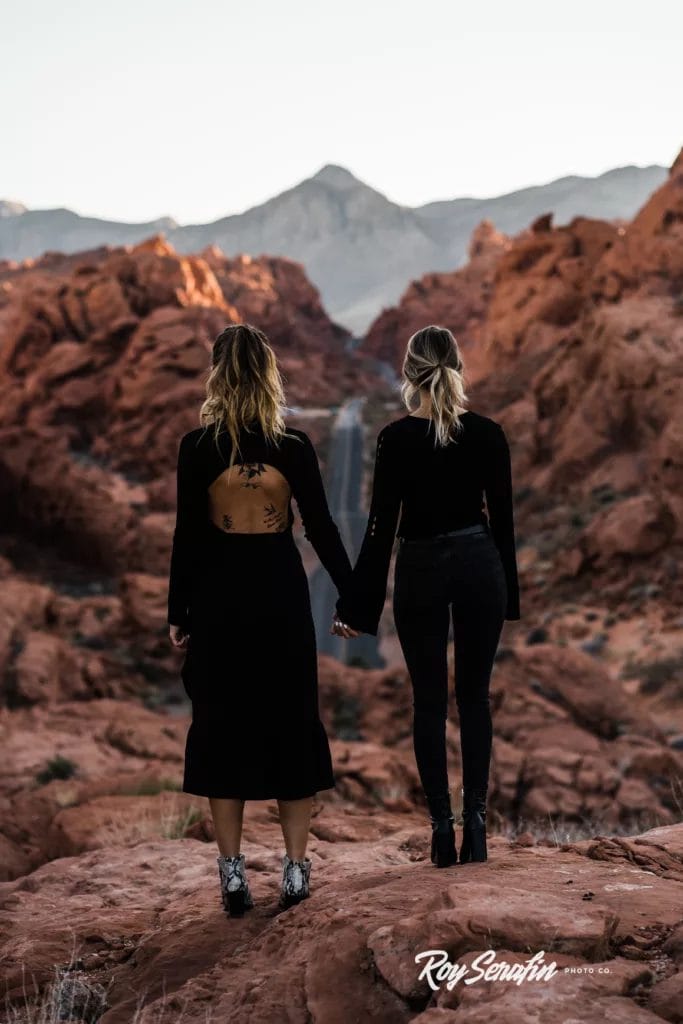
[0,164,667,335]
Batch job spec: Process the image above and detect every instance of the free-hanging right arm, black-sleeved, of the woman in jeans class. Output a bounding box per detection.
[484,423,521,620]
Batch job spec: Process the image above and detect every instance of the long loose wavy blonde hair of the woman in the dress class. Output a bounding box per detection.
[200,324,295,466]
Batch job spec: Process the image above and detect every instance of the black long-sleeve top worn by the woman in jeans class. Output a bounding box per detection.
[337,410,521,636]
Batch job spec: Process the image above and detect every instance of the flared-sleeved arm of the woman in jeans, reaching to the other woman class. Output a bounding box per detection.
[337,427,401,636]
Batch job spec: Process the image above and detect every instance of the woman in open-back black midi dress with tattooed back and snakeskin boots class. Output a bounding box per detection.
[168,324,351,914]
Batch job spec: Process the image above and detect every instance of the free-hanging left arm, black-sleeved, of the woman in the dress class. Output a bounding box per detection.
[168,433,206,633]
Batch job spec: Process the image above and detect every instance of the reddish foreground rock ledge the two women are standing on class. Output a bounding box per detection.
[0,805,683,1024]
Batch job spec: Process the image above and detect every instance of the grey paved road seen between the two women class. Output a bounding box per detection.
[309,398,384,668]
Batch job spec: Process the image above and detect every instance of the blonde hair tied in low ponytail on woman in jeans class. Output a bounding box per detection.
[400,324,469,446]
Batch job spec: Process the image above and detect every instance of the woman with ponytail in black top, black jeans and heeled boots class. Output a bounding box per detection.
[332,326,520,867]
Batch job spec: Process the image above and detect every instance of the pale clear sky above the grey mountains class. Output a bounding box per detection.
[0,0,683,223]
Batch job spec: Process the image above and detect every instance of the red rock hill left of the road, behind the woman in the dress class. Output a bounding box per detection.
[0,238,387,572]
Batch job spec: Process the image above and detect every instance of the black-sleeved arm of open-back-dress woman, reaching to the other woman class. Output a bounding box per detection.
[291,431,351,594]
